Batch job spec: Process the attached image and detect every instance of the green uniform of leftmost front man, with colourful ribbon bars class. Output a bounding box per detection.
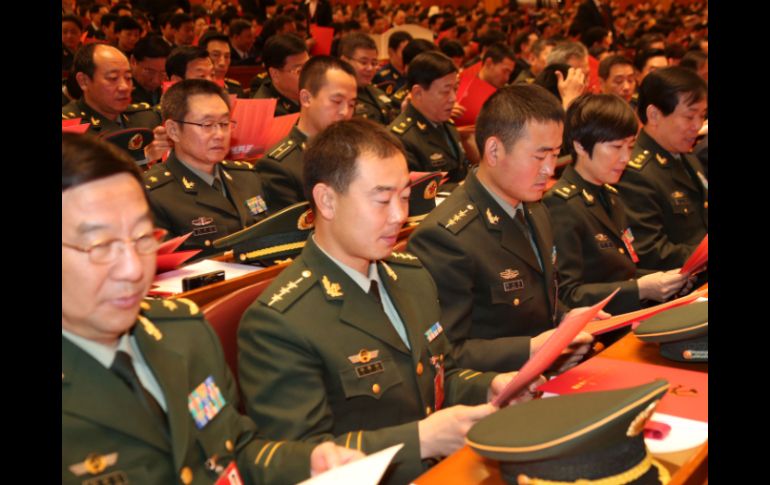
[62,300,315,484]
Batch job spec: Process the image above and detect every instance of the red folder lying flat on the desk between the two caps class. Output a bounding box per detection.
[538,356,708,422]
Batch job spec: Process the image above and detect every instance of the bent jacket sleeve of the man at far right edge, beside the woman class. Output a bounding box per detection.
[617,169,695,271]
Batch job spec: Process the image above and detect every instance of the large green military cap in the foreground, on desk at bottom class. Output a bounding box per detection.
[466,379,669,485]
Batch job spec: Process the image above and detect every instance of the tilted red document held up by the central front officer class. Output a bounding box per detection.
[492,288,620,407]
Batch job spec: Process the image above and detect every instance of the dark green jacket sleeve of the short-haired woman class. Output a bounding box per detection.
[544,197,641,311]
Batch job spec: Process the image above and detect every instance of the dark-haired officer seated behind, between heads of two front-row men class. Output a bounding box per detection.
[390,51,469,190]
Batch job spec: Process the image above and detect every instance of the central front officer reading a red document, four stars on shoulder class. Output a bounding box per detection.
[238,119,536,484]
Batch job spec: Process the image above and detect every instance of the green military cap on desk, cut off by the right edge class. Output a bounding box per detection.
[634,301,709,362]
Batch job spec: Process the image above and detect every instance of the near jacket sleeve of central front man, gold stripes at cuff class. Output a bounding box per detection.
[238,302,424,476]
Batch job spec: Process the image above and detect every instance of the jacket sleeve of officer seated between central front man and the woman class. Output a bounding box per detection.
[408,226,530,370]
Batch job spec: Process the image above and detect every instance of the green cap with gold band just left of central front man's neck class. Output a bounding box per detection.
[214,202,315,266]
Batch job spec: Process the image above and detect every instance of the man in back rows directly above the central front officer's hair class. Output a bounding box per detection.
[339,32,395,125]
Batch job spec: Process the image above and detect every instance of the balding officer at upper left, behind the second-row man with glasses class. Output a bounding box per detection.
[62,43,170,163]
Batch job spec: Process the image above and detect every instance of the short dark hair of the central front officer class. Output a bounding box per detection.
[302,118,404,209]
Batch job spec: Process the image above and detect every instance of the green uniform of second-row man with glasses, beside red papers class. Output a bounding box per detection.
[144,153,271,258]
